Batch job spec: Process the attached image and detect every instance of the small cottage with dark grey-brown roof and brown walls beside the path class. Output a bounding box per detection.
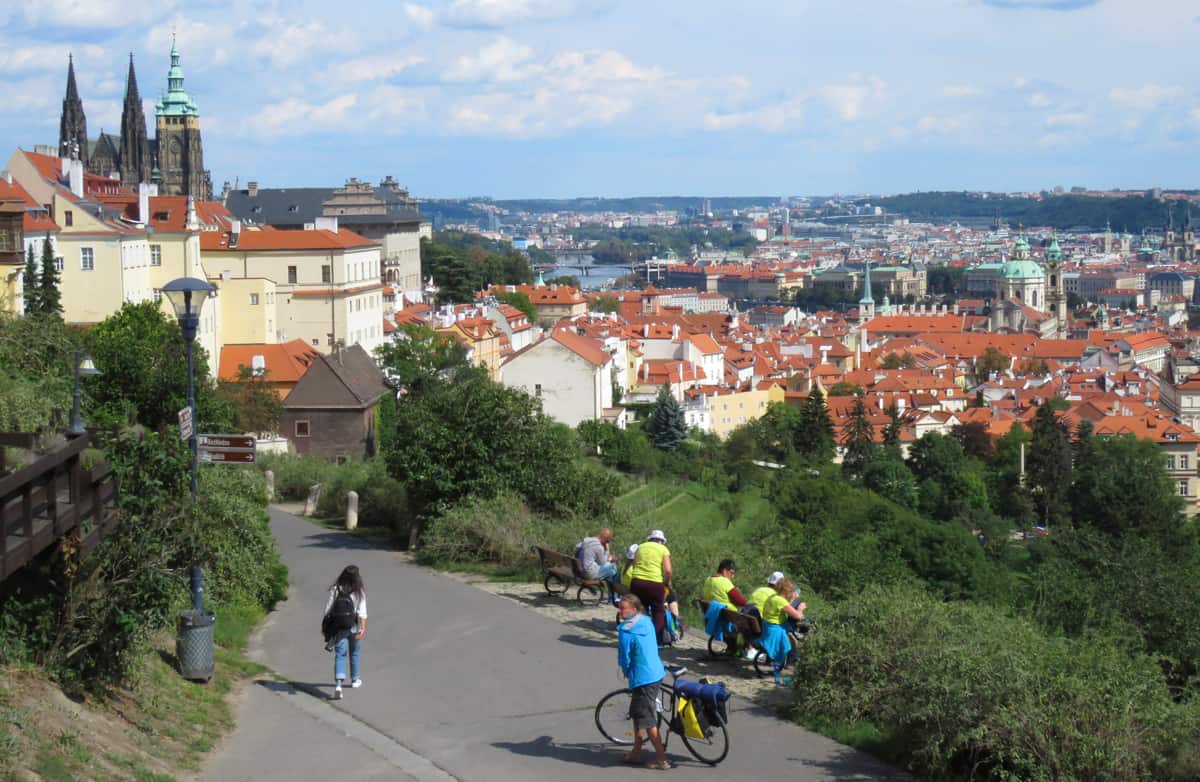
[280,344,391,459]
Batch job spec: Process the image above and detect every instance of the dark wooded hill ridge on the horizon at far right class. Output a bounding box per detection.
[869,192,1200,233]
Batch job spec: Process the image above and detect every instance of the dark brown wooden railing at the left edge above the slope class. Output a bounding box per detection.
[0,433,118,581]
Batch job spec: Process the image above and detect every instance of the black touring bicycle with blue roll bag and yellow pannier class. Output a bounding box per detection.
[595,668,730,765]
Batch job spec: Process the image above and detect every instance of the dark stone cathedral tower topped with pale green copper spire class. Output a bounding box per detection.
[155,38,209,200]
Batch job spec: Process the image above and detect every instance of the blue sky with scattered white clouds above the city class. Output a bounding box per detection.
[0,0,1200,198]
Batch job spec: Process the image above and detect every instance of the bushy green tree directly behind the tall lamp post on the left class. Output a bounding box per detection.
[86,301,233,432]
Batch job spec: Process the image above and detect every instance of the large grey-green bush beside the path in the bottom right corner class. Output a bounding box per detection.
[793,588,1200,780]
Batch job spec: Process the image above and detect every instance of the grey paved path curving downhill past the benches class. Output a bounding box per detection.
[198,509,906,782]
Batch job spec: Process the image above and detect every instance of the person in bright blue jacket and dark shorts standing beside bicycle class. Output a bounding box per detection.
[617,595,671,769]
